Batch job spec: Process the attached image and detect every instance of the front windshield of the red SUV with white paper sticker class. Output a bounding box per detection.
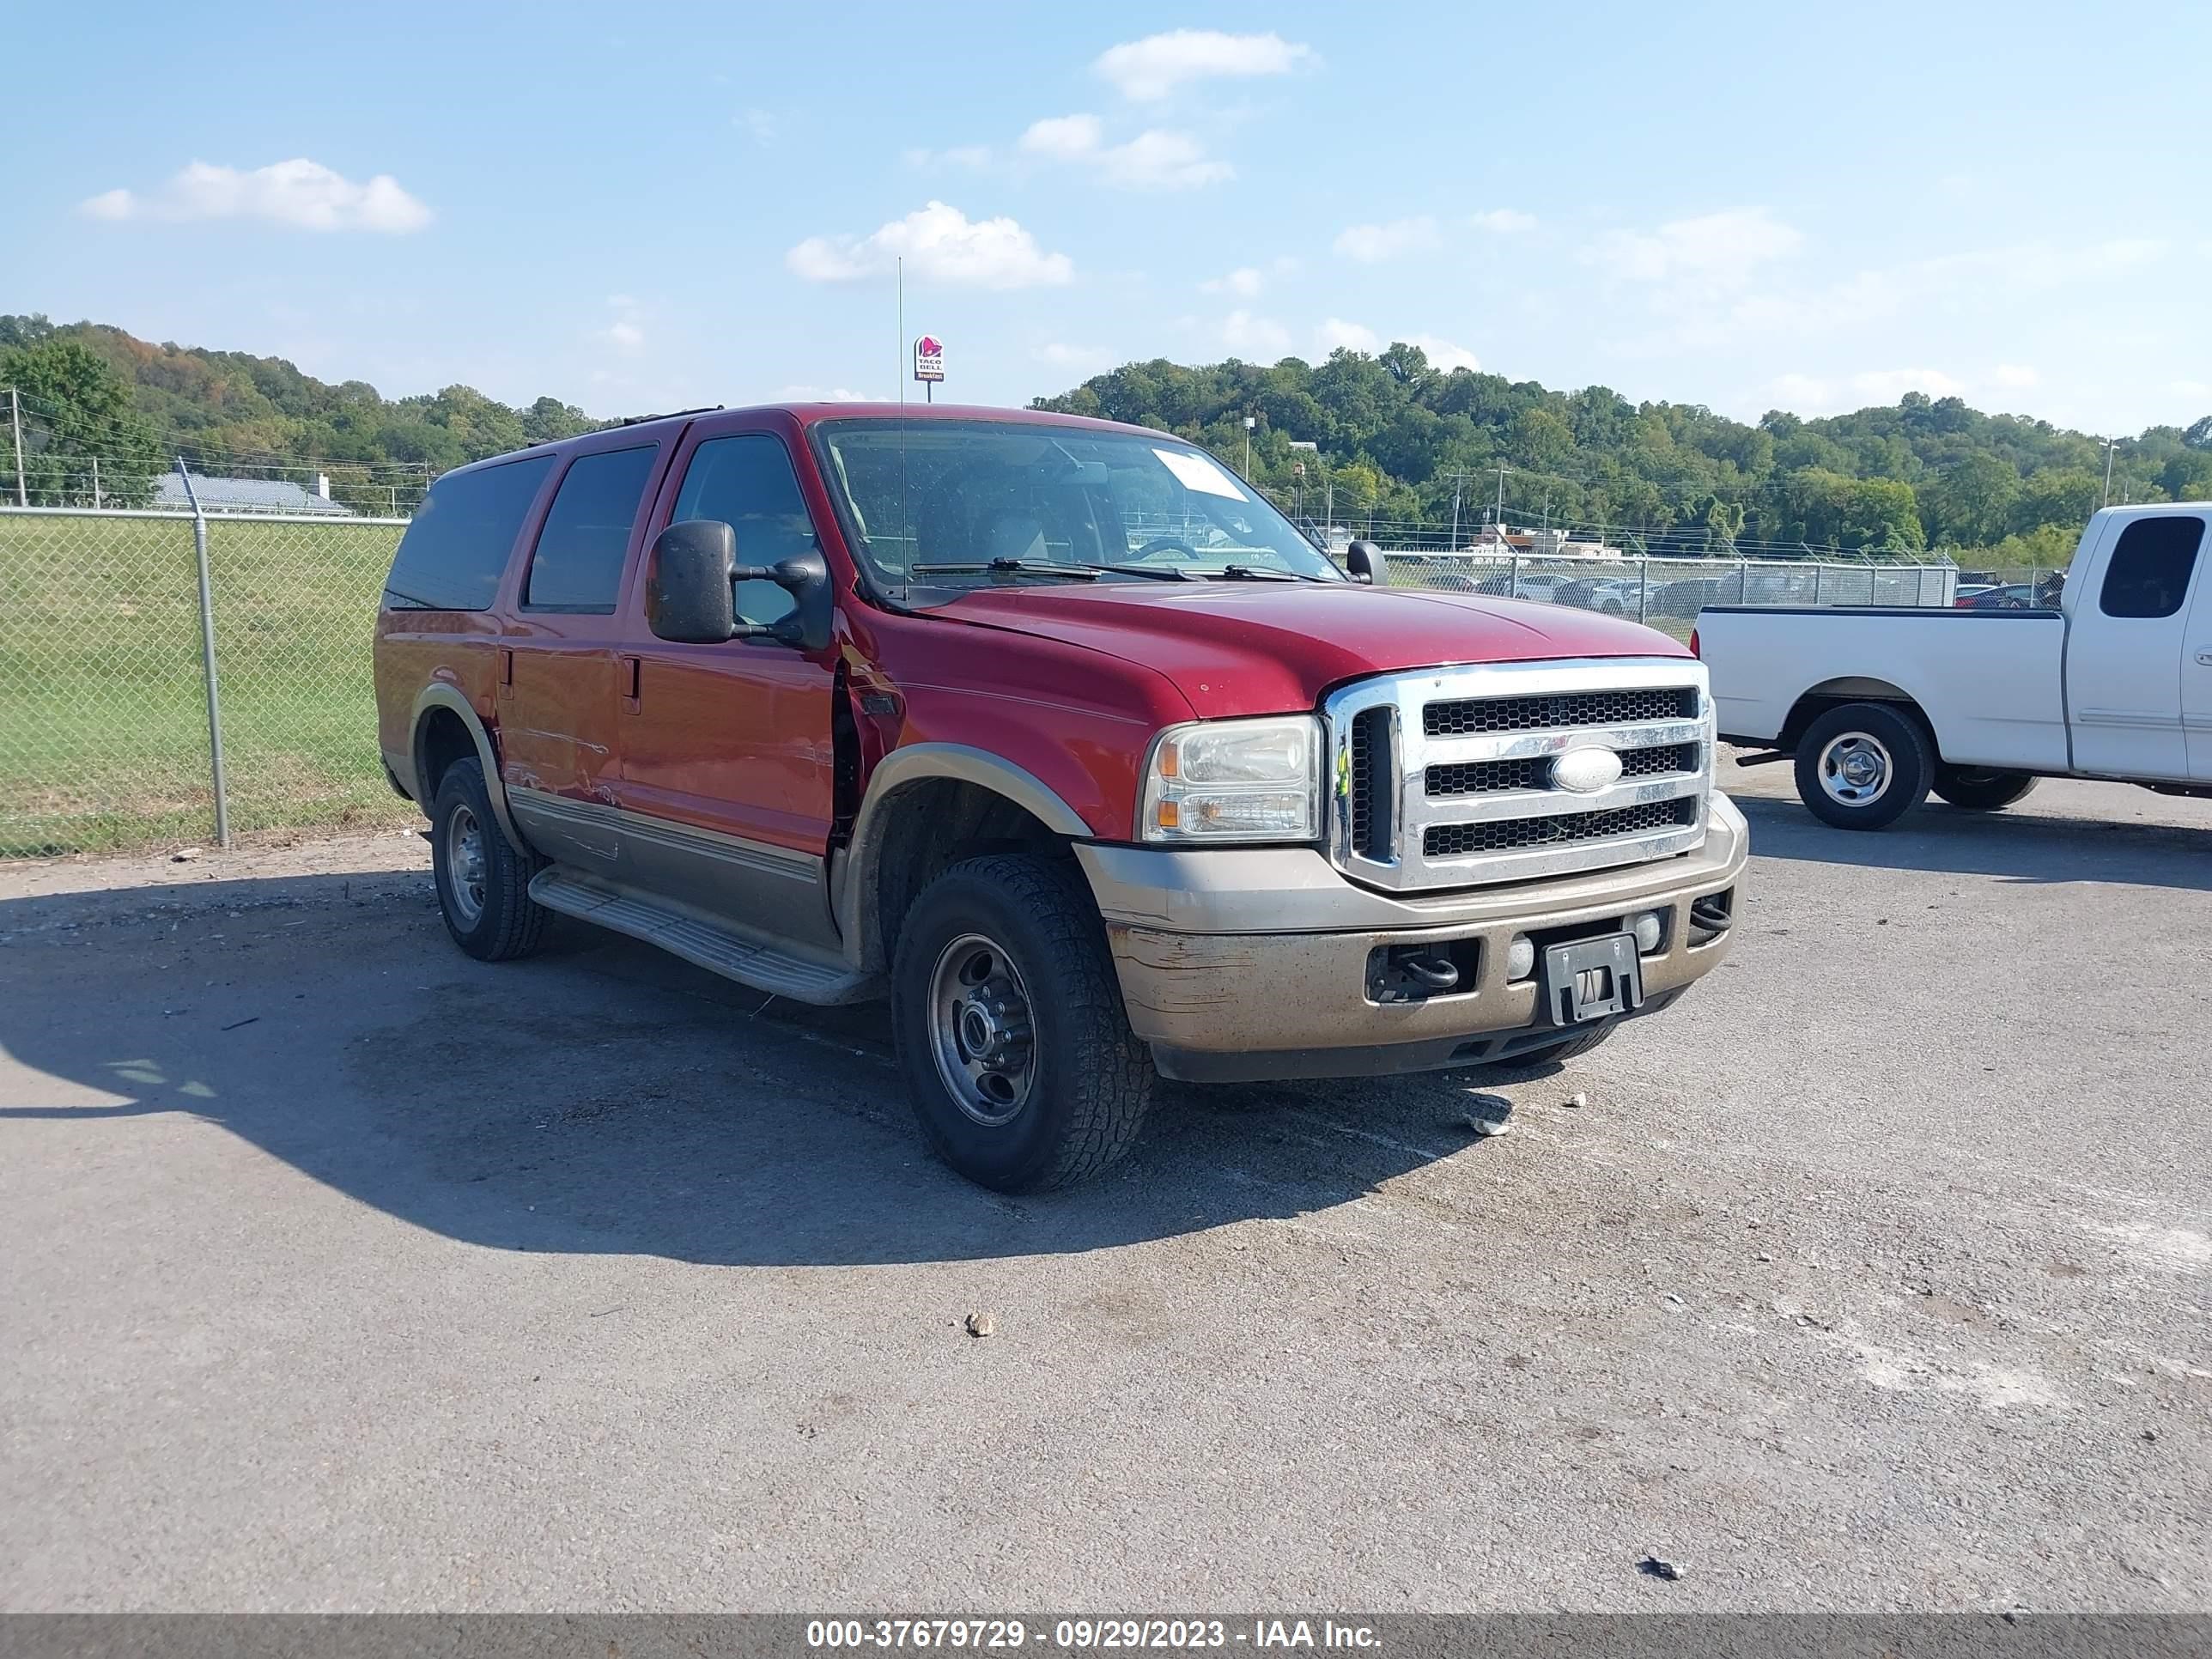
[814,420,1340,584]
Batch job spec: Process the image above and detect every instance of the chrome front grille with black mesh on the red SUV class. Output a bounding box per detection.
[1322,657,1712,890]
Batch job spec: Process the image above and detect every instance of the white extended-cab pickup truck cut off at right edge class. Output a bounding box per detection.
[1690,502,2212,830]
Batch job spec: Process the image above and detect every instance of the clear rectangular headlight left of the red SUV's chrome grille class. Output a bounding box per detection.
[1137,714,1321,841]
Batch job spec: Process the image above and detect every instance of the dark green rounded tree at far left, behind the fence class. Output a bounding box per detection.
[0,334,161,507]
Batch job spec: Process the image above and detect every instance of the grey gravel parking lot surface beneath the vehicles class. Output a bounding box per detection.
[0,768,2212,1610]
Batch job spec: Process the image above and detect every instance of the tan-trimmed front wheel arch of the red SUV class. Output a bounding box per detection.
[832,744,1093,973]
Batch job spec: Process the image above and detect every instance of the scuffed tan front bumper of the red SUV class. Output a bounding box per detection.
[1078,794,1750,1082]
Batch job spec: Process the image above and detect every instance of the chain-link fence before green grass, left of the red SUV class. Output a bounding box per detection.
[0,507,411,858]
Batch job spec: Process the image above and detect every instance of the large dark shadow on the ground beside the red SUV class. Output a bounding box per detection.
[0,874,1489,1267]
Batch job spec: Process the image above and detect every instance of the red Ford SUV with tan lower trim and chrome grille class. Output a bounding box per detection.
[376,404,1747,1192]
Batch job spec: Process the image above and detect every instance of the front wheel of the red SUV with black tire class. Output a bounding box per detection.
[891,854,1152,1192]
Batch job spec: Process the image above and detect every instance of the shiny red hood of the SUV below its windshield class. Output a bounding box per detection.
[929,581,1690,719]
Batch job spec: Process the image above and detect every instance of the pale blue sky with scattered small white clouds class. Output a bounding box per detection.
[0,0,2212,431]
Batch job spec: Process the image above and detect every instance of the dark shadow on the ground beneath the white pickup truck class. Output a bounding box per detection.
[1729,794,2212,891]
